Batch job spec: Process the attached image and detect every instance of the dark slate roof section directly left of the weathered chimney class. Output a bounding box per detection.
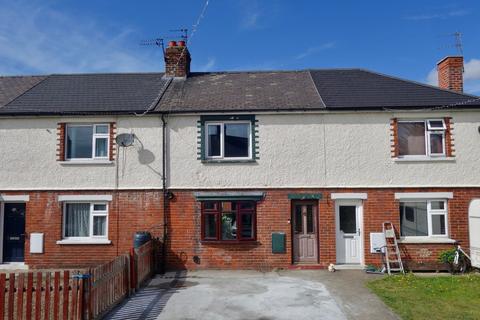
[0,73,169,115]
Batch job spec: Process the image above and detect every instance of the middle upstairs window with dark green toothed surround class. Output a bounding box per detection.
[198,115,258,162]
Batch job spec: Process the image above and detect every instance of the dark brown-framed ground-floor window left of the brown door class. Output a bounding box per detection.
[201,201,256,242]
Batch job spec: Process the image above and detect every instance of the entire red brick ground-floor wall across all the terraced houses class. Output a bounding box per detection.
[2,188,480,270]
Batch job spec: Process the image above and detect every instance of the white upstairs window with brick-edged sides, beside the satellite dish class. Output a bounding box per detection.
[65,123,110,160]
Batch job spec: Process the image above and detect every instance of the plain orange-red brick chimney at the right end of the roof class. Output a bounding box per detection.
[437,56,463,92]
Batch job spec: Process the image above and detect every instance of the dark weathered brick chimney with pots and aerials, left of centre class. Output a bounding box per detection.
[165,41,192,78]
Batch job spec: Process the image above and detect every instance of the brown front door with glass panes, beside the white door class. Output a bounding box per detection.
[292,201,318,263]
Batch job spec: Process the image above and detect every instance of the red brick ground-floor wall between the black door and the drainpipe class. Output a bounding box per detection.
[19,191,163,268]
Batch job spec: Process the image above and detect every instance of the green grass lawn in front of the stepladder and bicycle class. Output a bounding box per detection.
[367,274,480,320]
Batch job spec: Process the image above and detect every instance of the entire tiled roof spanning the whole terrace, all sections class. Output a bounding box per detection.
[0,69,480,115]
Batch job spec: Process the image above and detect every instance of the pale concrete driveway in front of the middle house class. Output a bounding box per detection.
[106,270,399,320]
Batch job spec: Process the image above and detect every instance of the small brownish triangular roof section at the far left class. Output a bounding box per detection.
[0,76,46,107]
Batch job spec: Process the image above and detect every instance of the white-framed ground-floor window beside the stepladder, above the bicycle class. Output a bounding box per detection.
[400,199,448,238]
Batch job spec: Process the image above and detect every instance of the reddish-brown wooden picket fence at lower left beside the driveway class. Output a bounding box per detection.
[0,241,154,320]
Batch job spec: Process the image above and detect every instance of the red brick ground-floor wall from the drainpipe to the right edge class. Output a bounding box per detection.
[164,188,480,270]
